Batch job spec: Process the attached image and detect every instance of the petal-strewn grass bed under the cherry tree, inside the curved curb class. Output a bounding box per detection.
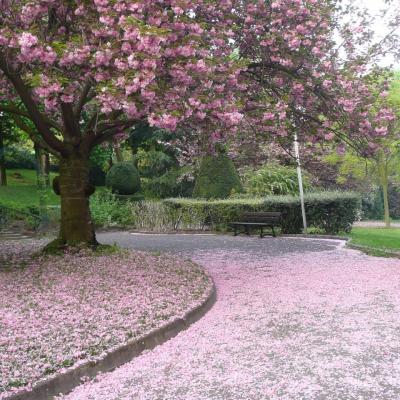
[0,241,212,399]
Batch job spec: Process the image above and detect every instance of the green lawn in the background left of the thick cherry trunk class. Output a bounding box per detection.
[0,169,60,207]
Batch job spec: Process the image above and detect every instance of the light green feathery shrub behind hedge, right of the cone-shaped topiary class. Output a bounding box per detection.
[244,163,310,197]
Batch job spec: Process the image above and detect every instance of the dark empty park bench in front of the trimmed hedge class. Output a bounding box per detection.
[229,212,282,238]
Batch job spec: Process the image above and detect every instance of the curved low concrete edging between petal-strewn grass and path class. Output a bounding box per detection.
[4,282,217,400]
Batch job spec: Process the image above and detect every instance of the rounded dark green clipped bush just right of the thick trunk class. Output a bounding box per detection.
[106,162,140,195]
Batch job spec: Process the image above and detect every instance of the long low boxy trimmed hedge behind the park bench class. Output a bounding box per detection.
[164,192,360,234]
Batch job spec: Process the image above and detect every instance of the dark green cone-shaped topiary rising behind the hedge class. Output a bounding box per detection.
[193,154,243,199]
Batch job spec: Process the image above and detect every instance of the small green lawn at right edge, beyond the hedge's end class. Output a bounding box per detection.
[350,228,400,251]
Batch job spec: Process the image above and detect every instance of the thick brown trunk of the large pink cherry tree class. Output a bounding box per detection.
[55,156,97,246]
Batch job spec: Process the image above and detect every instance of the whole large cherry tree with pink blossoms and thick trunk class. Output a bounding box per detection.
[0,0,398,244]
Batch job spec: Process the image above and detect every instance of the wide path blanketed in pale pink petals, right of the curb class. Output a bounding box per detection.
[60,239,400,400]
